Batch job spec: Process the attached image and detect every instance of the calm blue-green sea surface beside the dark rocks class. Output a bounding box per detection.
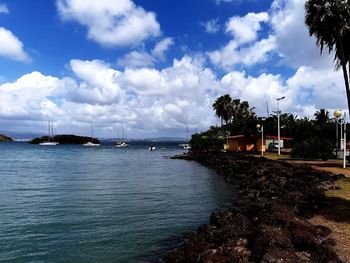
[0,143,233,263]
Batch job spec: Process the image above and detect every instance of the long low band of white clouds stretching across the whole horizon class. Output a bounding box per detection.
[0,56,346,137]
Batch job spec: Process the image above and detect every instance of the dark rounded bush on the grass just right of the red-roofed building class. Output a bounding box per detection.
[292,137,334,160]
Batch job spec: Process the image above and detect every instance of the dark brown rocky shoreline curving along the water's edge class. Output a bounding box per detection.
[161,151,343,263]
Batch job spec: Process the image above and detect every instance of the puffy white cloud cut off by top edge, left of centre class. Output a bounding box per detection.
[57,0,160,47]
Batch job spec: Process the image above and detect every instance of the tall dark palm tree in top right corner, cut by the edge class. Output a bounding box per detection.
[305,0,350,111]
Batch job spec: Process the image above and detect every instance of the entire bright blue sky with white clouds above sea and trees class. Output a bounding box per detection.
[0,0,347,138]
